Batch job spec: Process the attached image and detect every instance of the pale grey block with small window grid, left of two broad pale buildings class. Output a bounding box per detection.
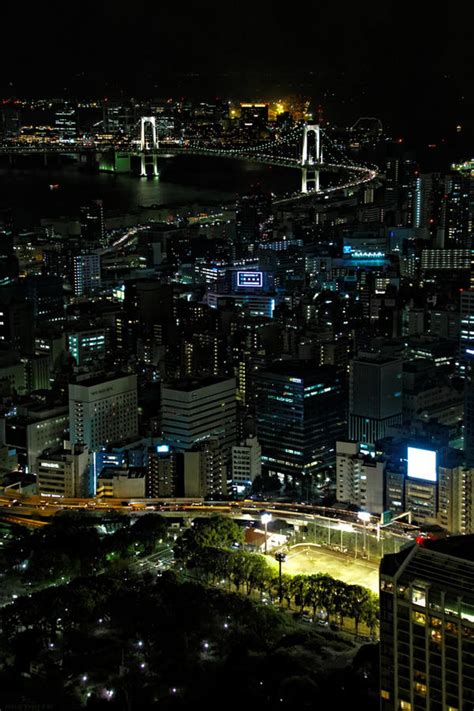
[69,375,138,452]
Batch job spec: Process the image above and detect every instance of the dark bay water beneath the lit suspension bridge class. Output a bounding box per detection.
[0,156,300,227]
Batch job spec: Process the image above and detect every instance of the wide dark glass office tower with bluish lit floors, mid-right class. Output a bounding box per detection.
[253,368,346,481]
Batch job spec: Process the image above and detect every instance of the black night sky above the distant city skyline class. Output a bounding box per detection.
[0,0,474,140]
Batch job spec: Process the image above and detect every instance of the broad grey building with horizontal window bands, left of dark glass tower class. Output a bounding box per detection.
[161,377,236,458]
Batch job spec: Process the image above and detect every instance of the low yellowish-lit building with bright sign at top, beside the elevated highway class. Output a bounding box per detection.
[37,444,92,498]
